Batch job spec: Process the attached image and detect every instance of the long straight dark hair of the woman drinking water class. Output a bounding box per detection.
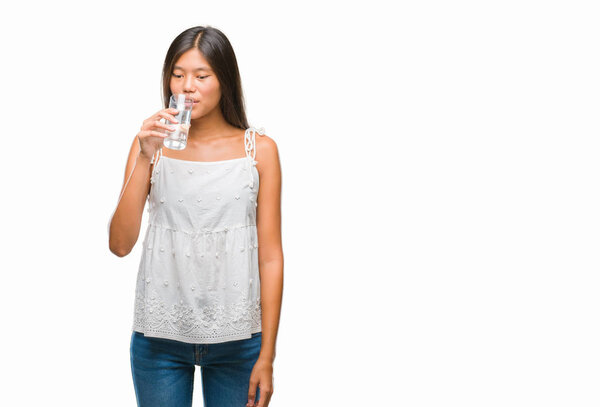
[162,26,248,130]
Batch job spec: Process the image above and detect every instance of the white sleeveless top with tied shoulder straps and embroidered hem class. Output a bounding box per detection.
[133,127,264,343]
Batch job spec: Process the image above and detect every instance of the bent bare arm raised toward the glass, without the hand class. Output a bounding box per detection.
[108,136,152,257]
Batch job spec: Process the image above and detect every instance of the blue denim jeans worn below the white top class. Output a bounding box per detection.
[130,331,262,407]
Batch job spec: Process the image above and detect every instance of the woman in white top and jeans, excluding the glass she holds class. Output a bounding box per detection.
[109,26,283,407]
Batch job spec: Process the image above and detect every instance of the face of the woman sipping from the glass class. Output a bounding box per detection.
[170,48,221,120]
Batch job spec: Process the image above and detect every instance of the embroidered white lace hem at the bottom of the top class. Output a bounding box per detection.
[133,292,261,343]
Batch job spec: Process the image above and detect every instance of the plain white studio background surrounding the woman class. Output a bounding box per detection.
[0,0,600,407]
